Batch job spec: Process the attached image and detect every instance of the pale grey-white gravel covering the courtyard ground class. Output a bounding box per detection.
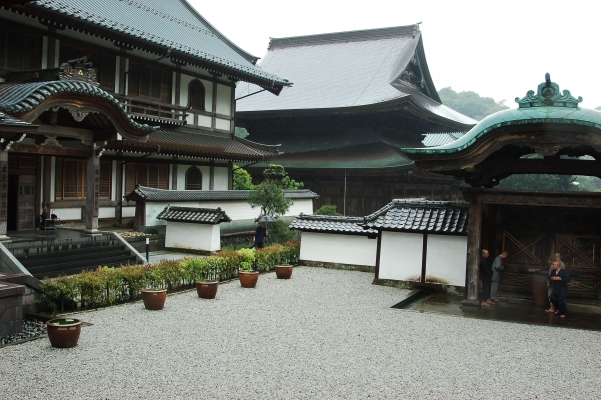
[0,267,601,399]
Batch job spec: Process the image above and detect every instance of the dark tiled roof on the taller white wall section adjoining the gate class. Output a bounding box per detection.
[365,199,468,235]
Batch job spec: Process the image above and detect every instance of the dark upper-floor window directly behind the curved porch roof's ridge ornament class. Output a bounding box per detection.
[59,43,117,92]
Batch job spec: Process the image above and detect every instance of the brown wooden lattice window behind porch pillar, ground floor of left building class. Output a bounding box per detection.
[54,157,113,201]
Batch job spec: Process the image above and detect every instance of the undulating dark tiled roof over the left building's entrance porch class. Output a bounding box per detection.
[0,81,157,134]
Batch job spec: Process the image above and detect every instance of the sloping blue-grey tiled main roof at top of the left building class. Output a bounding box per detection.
[27,0,289,91]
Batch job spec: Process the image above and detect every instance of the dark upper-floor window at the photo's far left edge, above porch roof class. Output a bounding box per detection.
[0,29,42,71]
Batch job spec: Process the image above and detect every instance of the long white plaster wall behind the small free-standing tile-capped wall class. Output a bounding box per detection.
[146,199,313,233]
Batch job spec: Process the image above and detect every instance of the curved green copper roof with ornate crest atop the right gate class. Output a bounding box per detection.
[402,74,601,155]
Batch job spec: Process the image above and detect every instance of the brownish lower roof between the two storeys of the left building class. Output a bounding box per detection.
[107,129,278,161]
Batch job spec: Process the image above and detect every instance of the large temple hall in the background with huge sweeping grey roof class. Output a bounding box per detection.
[236,25,476,216]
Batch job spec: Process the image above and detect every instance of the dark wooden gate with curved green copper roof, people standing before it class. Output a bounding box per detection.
[403,74,601,306]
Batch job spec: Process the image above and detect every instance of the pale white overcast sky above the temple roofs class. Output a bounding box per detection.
[189,0,601,108]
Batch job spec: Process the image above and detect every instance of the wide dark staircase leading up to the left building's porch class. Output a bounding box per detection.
[6,234,137,279]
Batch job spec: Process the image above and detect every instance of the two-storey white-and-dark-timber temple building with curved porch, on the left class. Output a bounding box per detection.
[0,0,290,239]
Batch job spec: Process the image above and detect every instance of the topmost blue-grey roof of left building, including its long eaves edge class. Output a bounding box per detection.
[12,0,291,94]
